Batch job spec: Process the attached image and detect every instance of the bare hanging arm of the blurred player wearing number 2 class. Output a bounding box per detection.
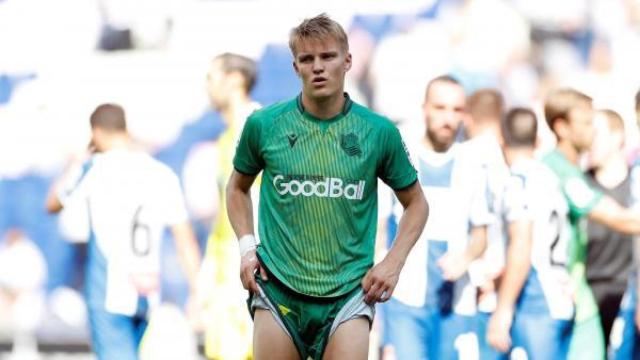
[487,220,532,352]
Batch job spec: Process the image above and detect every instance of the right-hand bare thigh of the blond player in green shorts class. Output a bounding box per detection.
[324,317,369,360]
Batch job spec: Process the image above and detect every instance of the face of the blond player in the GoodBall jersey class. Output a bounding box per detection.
[293,38,351,100]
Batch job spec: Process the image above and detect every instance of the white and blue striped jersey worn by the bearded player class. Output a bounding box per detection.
[394,144,495,315]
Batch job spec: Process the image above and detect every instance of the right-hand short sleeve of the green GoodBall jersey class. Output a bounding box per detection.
[378,127,418,190]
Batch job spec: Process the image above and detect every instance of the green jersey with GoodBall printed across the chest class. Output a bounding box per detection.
[233,94,417,297]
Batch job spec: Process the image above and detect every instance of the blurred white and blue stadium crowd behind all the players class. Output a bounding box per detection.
[0,0,640,355]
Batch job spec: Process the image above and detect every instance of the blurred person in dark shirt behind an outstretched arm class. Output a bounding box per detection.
[587,110,633,350]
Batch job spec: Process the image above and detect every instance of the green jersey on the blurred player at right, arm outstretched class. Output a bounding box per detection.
[543,150,602,322]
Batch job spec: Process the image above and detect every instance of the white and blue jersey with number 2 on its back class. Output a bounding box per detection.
[503,159,574,320]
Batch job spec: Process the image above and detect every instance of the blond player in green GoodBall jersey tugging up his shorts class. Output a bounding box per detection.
[227,14,428,360]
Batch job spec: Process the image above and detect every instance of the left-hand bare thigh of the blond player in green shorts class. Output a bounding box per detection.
[253,309,300,360]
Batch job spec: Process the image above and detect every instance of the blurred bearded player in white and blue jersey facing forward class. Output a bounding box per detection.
[385,75,493,359]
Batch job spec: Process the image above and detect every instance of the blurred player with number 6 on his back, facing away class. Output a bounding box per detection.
[46,104,200,360]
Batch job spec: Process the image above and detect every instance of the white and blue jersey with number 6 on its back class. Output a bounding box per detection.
[58,149,187,315]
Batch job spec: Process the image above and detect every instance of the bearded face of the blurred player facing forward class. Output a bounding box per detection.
[422,81,467,151]
